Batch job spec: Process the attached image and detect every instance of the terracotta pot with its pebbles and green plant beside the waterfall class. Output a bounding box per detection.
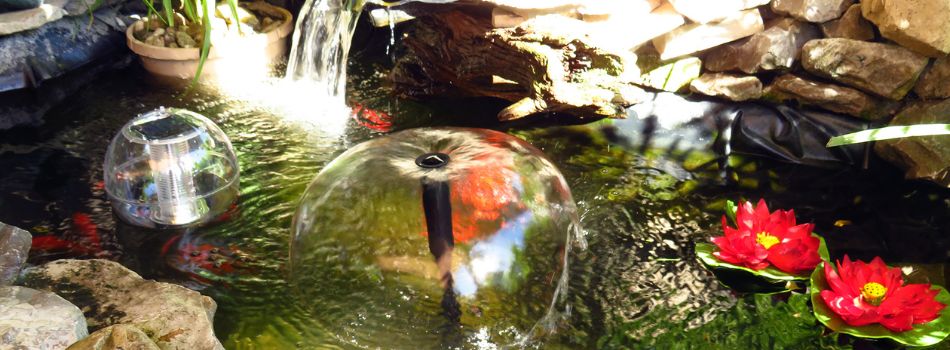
[126,0,294,79]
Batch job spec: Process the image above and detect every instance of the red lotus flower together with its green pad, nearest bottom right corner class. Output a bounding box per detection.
[810,255,950,346]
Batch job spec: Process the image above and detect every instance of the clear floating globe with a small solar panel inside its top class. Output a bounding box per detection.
[103,108,239,228]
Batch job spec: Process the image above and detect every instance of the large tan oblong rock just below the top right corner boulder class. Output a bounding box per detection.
[802,38,927,100]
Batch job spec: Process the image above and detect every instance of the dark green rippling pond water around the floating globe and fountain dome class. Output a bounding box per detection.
[0,25,950,349]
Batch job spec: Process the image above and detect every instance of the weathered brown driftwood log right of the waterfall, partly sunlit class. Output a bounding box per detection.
[393,11,644,121]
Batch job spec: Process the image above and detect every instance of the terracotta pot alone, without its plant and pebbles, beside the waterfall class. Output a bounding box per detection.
[125,2,294,79]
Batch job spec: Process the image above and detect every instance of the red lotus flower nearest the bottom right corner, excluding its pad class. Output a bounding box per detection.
[821,255,946,332]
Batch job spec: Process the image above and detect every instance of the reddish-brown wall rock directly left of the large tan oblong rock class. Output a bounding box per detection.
[704,18,821,74]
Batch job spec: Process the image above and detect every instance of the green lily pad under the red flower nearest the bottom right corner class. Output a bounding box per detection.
[809,262,950,346]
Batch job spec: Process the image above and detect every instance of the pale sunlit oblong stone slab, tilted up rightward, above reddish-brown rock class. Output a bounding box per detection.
[653,9,765,60]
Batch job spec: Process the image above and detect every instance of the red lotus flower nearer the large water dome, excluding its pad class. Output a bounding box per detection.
[712,200,821,275]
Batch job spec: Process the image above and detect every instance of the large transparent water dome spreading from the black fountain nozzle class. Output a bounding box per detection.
[290,128,578,348]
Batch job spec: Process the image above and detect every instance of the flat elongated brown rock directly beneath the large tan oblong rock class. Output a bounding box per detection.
[763,74,897,120]
